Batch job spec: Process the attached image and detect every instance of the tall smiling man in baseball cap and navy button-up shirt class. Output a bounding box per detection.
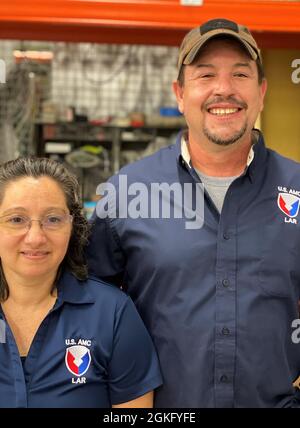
[88,19,300,408]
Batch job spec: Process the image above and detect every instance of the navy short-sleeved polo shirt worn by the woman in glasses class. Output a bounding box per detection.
[0,273,161,408]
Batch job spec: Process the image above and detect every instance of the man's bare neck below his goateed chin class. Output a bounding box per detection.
[187,131,254,177]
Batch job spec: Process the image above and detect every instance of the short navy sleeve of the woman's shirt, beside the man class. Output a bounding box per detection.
[108,297,162,404]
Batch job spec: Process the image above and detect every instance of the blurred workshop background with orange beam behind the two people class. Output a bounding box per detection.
[0,0,300,215]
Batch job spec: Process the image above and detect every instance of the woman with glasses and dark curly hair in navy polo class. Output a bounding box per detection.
[0,158,161,407]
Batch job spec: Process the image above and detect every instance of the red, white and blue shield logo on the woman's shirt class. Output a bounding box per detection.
[65,345,91,376]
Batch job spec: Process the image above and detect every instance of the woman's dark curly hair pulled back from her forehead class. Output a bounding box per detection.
[0,157,90,301]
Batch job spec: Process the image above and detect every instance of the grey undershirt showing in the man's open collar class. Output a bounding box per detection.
[195,169,239,213]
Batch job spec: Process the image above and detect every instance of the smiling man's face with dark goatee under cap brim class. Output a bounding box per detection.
[173,40,266,146]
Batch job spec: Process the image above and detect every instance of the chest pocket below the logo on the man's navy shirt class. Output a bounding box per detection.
[258,223,300,299]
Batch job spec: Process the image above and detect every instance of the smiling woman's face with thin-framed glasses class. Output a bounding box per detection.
[0,177,72,281]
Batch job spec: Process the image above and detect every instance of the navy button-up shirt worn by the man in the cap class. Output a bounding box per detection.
[88,131,300,407]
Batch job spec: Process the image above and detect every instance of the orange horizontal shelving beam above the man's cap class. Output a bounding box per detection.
[0,0,300,47]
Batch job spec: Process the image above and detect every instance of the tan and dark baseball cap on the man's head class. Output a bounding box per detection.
[177,18,262,74]
